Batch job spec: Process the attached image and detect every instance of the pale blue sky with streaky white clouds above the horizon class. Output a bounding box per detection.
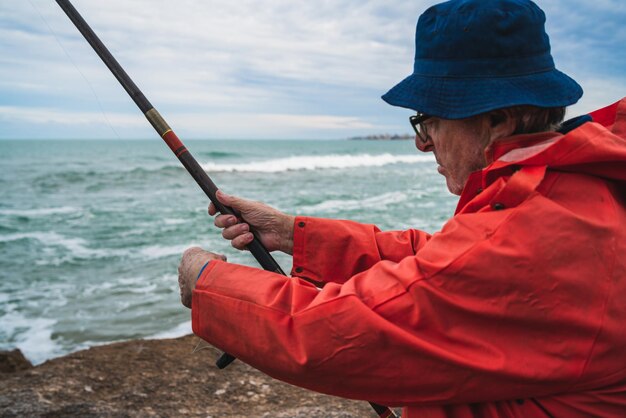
[0,0,626,140]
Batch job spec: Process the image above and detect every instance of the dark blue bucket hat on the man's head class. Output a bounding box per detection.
[382,0,583,119]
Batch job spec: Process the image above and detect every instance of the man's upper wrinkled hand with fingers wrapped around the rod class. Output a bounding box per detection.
[209,190,295,254]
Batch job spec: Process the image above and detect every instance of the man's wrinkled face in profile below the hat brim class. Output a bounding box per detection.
[415,117,490,195]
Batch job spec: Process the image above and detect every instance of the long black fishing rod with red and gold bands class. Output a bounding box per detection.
[55,0,396,418]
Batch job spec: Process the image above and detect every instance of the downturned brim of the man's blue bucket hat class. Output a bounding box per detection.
[382,69,583,119]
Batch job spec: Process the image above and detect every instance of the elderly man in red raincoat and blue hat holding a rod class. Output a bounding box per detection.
[180,0,626,418]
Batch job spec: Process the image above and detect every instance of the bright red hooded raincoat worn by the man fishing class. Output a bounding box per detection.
[192,99,626,418]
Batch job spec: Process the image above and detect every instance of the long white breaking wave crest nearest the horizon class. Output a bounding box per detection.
[202,154,434,173]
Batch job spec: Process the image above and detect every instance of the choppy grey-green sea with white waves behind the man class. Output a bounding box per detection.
[0,139,457,364]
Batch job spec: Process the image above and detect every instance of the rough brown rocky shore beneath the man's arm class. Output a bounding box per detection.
[0,335,386,418]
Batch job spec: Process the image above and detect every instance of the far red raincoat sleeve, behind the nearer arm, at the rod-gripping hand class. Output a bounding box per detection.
[291,217,431,283]
